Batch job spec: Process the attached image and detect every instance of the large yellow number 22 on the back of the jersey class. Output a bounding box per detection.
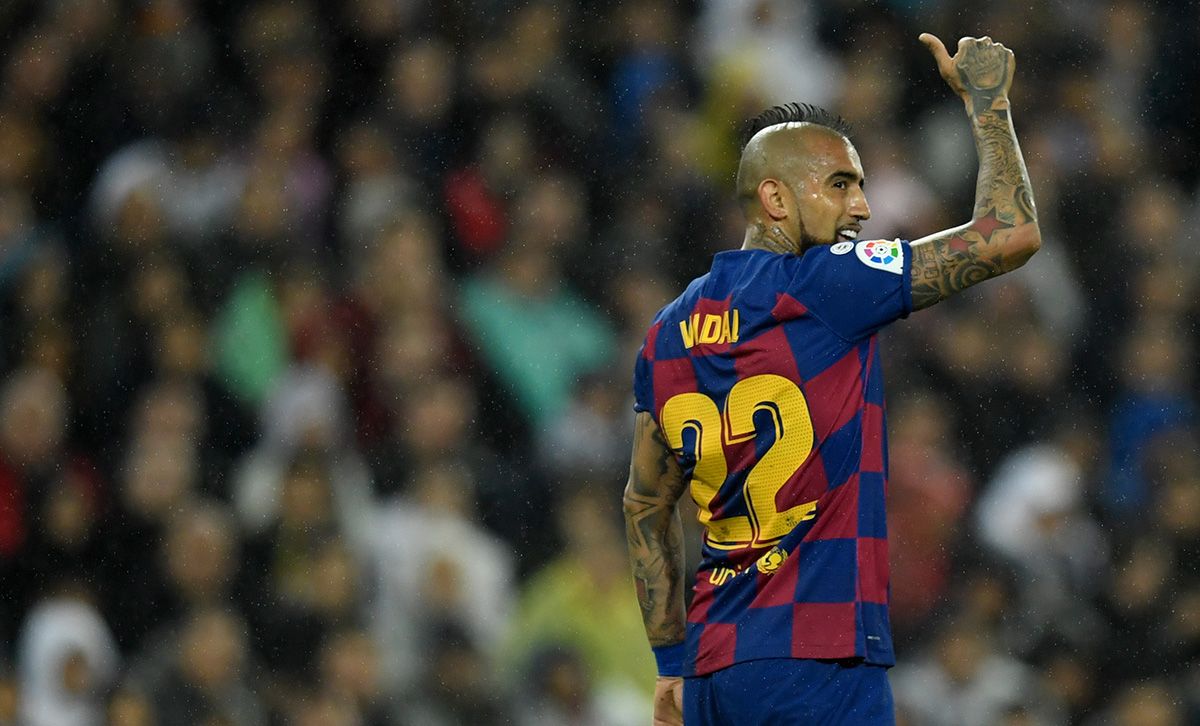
[660,374,817,550]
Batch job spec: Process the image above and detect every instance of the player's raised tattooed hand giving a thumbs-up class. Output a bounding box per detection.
[920,32,1016,112]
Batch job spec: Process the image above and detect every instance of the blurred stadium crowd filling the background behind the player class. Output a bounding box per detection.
[0,0,1200,726]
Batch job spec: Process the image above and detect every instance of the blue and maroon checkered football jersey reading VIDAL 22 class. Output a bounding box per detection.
[634,240,912,676]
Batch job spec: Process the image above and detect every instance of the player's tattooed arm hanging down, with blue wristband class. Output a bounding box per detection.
[625,413,684,726]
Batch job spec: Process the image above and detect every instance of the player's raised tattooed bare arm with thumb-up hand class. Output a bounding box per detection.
[912,32,1042,310]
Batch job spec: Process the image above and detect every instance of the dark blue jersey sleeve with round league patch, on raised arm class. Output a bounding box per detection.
[790,240,912,341]
